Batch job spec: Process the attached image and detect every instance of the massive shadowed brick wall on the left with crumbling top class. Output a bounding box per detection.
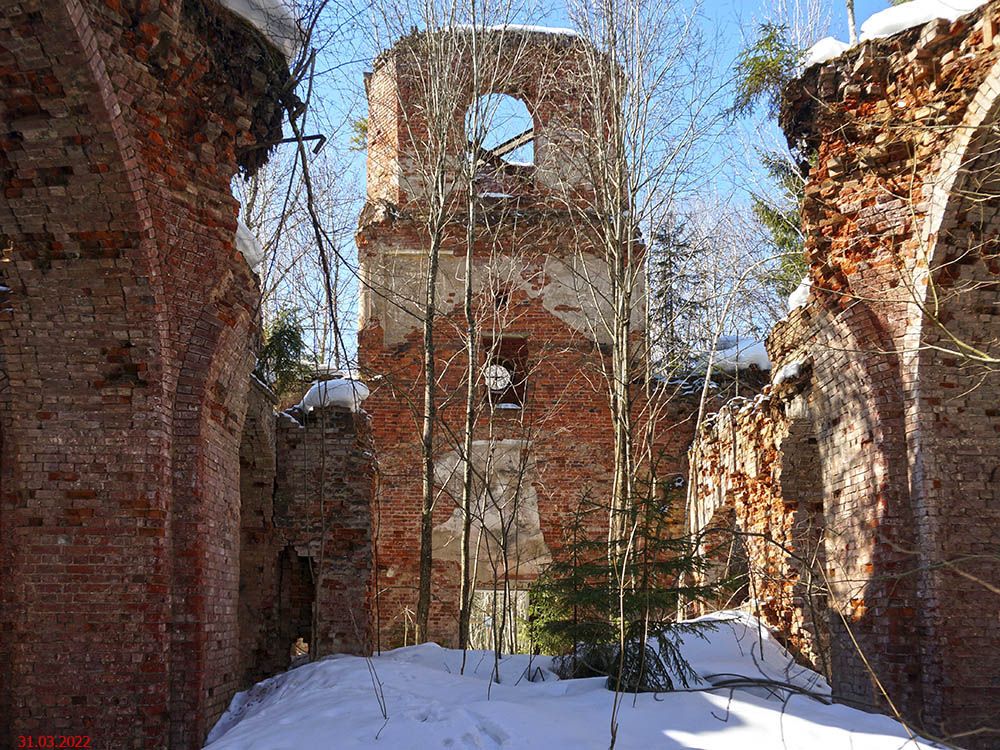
[0,0,288,748]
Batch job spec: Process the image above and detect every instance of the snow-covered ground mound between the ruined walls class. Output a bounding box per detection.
[206,612,935,750]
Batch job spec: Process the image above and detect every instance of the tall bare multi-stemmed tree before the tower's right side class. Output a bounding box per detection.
[556,0,723,746]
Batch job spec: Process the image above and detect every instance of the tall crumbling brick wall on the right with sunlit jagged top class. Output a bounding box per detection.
[697,2,1000,747]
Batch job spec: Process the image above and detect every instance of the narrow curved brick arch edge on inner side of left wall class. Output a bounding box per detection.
[170,266,257,746]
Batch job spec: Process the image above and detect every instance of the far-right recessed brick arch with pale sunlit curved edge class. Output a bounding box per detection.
[905,57,1000,733]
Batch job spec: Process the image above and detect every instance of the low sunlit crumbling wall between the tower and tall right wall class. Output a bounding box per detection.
[691,368,830,674]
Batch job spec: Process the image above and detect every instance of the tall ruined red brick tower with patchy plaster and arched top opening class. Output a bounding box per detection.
[358,27,664,647]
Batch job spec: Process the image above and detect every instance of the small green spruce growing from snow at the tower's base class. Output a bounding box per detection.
[528,487,714,692]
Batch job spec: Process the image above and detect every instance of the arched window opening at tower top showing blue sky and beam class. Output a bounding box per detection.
[465,94,535,167]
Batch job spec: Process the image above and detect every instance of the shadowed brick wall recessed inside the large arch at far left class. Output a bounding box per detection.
[0,0,169,745]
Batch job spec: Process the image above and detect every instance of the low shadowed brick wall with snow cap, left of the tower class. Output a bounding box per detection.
[240,381,374,687]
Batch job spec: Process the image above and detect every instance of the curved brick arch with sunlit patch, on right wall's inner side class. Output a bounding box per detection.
[798,290,922,715]
